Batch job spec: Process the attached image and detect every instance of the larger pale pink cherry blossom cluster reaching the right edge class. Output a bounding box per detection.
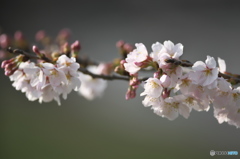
[124,41,240,127]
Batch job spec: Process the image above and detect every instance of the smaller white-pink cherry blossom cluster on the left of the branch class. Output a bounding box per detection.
[2,55,80,105]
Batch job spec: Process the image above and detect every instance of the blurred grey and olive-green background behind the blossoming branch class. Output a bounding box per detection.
[0,0,240,159]
